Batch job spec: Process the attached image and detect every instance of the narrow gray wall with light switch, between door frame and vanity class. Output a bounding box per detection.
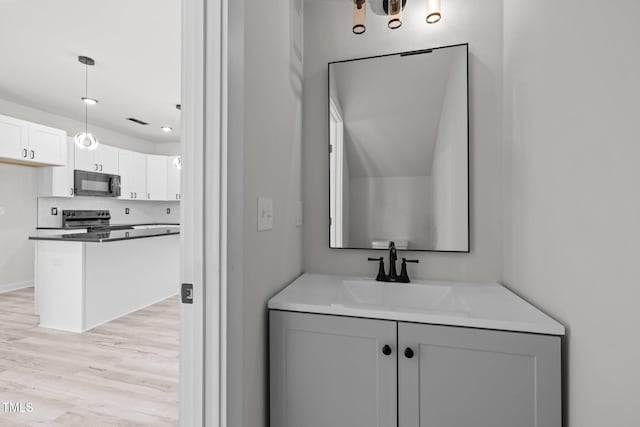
[240,0,302,427]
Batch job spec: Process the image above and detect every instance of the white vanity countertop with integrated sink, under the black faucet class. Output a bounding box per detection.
[268,274,565,335]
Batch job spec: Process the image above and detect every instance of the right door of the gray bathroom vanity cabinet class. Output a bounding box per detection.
[398,323,562,427]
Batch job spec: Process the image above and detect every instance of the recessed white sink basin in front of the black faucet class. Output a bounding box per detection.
[338,280,469,315]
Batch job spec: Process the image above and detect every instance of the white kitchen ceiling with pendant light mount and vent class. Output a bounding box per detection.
[0,0,180,142]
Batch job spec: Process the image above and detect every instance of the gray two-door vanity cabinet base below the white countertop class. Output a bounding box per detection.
[269,311,562,427]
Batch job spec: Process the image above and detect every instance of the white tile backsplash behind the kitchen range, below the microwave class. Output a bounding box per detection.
[38,197,180,228]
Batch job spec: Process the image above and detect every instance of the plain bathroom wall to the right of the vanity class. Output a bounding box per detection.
[504,0,640,427]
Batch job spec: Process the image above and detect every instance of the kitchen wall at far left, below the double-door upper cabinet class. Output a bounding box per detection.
[0,164,37,292]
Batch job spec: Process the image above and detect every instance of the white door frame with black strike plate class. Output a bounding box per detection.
[180,0,228,427]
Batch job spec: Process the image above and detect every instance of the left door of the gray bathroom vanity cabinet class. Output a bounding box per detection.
[270,311,397,427]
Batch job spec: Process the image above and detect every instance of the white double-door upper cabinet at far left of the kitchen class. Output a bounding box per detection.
[0,115,67,166]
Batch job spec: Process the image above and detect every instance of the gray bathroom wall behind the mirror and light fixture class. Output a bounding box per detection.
[303,0,503,280]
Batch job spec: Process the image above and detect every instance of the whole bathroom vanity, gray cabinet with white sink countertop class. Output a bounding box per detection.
[268,274,564,427]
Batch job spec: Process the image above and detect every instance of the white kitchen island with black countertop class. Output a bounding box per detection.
[30,226,180,332]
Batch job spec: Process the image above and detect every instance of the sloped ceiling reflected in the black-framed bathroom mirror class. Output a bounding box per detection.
[331,48,457,178]
